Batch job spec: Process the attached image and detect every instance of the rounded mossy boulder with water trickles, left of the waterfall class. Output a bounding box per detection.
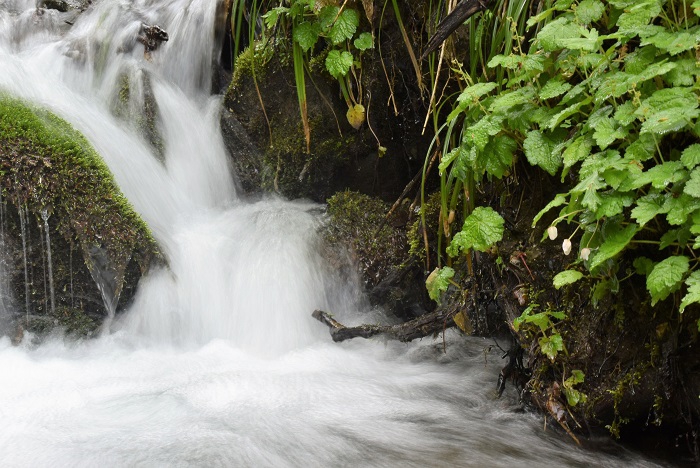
[0,95,159,332]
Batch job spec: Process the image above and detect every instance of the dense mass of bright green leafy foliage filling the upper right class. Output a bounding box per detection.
[432,0,700,326]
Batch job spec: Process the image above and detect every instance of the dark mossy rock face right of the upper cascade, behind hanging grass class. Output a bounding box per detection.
[222,37,430,202]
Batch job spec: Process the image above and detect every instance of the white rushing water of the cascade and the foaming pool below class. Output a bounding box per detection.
[0,0,668,467]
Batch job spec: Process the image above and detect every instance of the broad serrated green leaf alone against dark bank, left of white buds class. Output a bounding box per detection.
[447,206,504,257]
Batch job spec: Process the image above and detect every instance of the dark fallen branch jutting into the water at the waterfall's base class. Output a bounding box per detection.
[311,308,459,342]
